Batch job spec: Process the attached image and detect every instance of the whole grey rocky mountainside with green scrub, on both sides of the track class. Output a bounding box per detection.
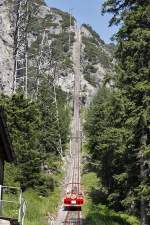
[0,0,113,104]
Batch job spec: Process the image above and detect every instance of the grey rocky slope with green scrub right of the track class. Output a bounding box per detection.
[80,25,113,105]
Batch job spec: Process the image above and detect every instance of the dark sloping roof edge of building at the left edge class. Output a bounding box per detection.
[0,107,15,162]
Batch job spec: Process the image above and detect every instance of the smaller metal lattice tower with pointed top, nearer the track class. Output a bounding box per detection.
[36,29,63,159]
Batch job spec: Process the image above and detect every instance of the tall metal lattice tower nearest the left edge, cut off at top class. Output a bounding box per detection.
[13,0,29,97]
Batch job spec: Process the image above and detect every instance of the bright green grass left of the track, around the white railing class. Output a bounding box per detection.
[2,175,62,225]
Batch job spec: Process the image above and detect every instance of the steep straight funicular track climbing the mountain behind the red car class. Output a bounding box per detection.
[55,27,82,225]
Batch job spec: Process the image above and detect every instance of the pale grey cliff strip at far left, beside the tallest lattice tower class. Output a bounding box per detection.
[0,0,14,95]
